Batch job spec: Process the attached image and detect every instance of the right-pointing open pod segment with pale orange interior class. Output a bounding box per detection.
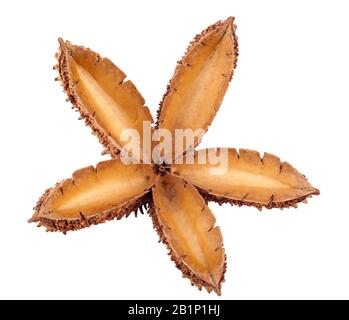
[171,148,319,208]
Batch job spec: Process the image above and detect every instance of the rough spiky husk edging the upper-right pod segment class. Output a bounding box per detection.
[155,18,239,129]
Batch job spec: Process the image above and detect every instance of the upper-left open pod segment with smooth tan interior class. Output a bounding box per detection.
[57,39,153,158]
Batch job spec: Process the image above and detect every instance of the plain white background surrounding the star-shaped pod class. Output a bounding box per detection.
[0,0,349,299]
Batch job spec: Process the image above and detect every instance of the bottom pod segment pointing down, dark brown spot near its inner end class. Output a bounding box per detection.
[152,174,225,294]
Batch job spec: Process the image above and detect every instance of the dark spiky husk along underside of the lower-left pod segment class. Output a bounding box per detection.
[29,188,151,233]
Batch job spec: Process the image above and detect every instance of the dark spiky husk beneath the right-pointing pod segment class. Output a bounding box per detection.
[195,186,320,210]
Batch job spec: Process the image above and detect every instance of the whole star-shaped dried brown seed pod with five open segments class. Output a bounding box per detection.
[30,18,319,294]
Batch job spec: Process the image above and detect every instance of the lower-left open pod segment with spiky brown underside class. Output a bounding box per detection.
[31,160,155,231]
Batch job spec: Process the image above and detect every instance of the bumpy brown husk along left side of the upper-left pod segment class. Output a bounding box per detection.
[56,40,120,157]
